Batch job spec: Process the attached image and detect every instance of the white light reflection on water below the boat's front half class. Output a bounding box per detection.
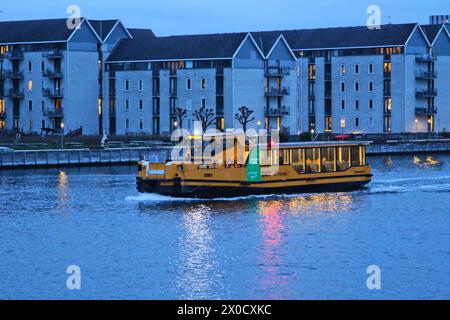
[176,205,217,300]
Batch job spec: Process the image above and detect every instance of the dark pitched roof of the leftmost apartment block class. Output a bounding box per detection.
[0,19,79,43]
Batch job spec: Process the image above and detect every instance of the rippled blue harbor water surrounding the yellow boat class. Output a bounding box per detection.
[0,154,450,299]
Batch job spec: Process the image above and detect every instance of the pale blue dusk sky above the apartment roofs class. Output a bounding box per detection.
[0,0,450,36]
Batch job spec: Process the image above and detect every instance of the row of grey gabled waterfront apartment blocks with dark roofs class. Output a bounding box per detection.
[0,19,450,135]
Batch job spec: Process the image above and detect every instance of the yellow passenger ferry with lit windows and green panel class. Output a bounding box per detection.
[136,133,372,199]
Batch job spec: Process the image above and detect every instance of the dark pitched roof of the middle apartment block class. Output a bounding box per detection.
[108,33,247,61]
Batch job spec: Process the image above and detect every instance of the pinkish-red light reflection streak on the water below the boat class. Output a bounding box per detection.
[259,201,289,300]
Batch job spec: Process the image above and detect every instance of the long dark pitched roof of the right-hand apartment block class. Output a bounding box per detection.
[251,23,417,50]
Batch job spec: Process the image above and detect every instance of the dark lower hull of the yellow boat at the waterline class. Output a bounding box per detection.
[137,175,371,199]
